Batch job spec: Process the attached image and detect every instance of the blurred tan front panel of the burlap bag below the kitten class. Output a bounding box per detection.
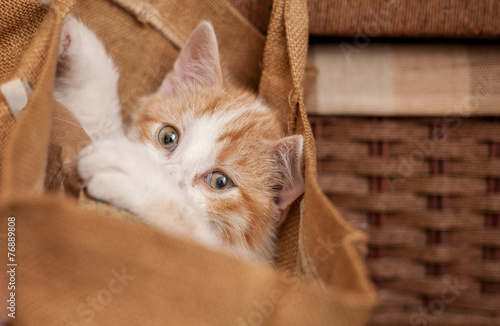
[0,196,378,326]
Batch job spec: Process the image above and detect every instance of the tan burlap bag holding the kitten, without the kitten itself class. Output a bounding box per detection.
[0,0,376,325]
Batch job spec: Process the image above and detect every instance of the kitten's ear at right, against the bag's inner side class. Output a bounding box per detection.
[270,135,304,226]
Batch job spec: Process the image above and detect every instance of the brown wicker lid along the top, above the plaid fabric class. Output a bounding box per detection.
[229,0,500,38]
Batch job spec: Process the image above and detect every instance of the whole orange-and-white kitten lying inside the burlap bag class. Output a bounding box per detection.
[54,16,303,262]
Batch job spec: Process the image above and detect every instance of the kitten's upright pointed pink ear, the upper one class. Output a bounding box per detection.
[158,21,224,97]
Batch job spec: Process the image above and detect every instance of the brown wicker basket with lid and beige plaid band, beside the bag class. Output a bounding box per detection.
[231,0,500,325]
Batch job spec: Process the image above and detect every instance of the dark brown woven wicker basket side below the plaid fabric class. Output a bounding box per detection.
[310,115,500,326]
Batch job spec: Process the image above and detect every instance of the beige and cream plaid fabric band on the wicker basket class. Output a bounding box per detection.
[306,42,500,117]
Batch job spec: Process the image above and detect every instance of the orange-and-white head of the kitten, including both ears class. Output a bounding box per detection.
[130,23,303,260]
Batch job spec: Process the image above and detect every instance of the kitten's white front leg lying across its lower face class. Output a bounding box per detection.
[78,138,220,248]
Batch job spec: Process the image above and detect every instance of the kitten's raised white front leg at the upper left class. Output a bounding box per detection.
[54,14,123,141]
